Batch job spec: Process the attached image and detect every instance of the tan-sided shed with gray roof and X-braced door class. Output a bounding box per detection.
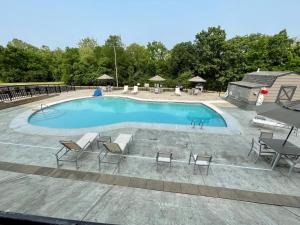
[227,71,300,105]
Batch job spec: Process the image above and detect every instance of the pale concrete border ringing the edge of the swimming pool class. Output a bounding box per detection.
[9,95,243,136]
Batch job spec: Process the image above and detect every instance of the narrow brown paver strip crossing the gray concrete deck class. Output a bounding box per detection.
[0,162,300,208]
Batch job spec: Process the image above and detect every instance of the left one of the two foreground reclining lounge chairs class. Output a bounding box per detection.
[55,133,99,169]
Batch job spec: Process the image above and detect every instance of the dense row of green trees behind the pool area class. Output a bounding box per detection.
[0,27,300,90]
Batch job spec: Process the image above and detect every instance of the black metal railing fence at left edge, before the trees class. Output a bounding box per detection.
[0,85,75,102]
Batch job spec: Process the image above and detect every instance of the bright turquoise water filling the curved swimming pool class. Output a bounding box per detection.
[29,97,226,128]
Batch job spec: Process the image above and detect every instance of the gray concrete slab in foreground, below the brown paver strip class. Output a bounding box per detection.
[0,172,300,225]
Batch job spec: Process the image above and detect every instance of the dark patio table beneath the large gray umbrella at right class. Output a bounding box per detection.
[261,138,300,170]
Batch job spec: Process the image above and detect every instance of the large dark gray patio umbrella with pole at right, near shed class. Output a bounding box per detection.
[256,101,300,145]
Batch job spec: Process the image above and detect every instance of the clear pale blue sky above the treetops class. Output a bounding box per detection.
[0,0,300,49]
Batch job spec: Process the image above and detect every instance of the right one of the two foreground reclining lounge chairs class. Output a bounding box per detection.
[98,134,133,170]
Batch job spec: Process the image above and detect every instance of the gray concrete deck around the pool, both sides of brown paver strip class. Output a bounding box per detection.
[0,90,300,225]
